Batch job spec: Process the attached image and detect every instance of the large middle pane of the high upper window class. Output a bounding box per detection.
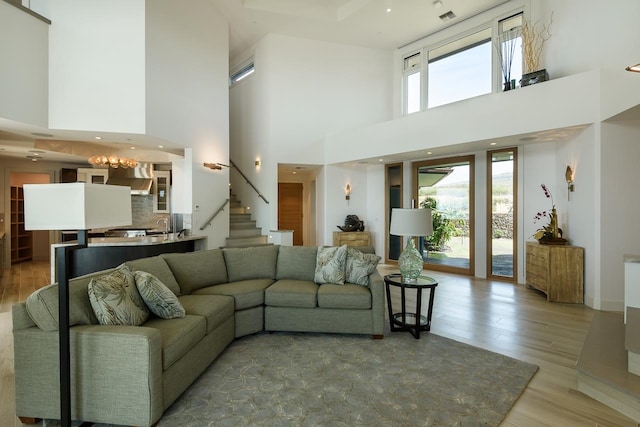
[427,28,492,108]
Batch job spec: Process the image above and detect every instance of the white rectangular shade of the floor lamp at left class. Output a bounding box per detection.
[23,182,132,230]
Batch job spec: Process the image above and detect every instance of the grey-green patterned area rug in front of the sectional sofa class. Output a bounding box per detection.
[159,333,538,427]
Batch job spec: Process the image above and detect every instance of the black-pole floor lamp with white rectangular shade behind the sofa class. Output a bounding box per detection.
[23,182,131,427]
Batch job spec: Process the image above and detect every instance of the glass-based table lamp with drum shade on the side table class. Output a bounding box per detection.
[389,208,433,283]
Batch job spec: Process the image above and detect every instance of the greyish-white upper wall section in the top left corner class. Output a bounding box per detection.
[0,2,49,126]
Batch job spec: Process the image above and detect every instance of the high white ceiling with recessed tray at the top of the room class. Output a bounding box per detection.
[211,0,507,60]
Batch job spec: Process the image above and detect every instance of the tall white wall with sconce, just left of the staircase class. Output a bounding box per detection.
[145,0,229,248]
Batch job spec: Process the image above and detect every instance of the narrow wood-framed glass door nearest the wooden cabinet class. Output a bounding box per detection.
[487,148,518,281]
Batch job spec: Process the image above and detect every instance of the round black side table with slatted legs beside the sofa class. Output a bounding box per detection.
[384,274,438,339]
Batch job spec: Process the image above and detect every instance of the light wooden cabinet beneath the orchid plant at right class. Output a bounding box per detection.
[527,242,584,303]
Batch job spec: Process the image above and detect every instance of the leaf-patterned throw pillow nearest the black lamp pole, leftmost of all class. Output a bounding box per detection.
[88,265,149,326]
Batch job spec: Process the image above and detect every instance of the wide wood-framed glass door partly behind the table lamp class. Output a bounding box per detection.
[414,156,474,274]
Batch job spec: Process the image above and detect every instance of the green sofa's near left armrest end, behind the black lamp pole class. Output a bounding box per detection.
[14,325,163,425]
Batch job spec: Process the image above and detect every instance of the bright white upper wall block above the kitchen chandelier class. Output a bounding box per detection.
[49,0,145,133]
